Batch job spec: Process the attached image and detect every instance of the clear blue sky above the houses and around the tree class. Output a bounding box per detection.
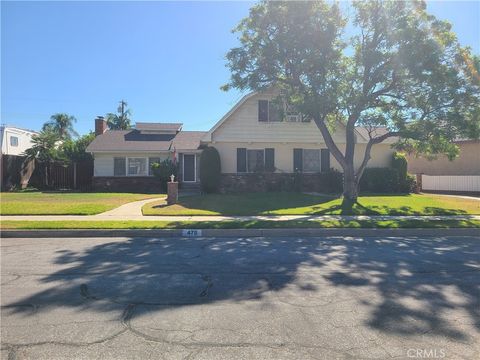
[1,1,480,134]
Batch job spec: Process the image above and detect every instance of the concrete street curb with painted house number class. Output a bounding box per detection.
[1,228,480,238]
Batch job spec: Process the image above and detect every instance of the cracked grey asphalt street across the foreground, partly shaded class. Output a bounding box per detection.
[1,237,480,360]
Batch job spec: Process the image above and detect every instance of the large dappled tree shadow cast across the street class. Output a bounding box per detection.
[4,237,480,340]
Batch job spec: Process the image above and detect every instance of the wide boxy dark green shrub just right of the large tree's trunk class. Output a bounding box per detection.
[360,168,400,193]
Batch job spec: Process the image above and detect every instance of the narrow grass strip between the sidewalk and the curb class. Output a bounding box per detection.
[1,219,480,230]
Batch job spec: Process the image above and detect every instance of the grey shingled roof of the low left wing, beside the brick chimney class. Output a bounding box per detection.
[87,129,205,152]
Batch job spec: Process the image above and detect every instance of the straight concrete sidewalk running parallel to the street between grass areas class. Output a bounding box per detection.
[0,213,480,221]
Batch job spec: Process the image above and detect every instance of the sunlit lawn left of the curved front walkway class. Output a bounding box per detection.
[0,192,162,215]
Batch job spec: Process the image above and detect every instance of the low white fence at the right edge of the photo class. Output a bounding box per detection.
[422,175,480,192]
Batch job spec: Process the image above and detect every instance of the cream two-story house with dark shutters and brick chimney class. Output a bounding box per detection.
[87,92,393,191]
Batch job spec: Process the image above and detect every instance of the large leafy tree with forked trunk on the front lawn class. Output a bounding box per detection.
[223,1,480,203]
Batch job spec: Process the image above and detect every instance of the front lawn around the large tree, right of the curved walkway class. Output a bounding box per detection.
[142,193,480,215]
